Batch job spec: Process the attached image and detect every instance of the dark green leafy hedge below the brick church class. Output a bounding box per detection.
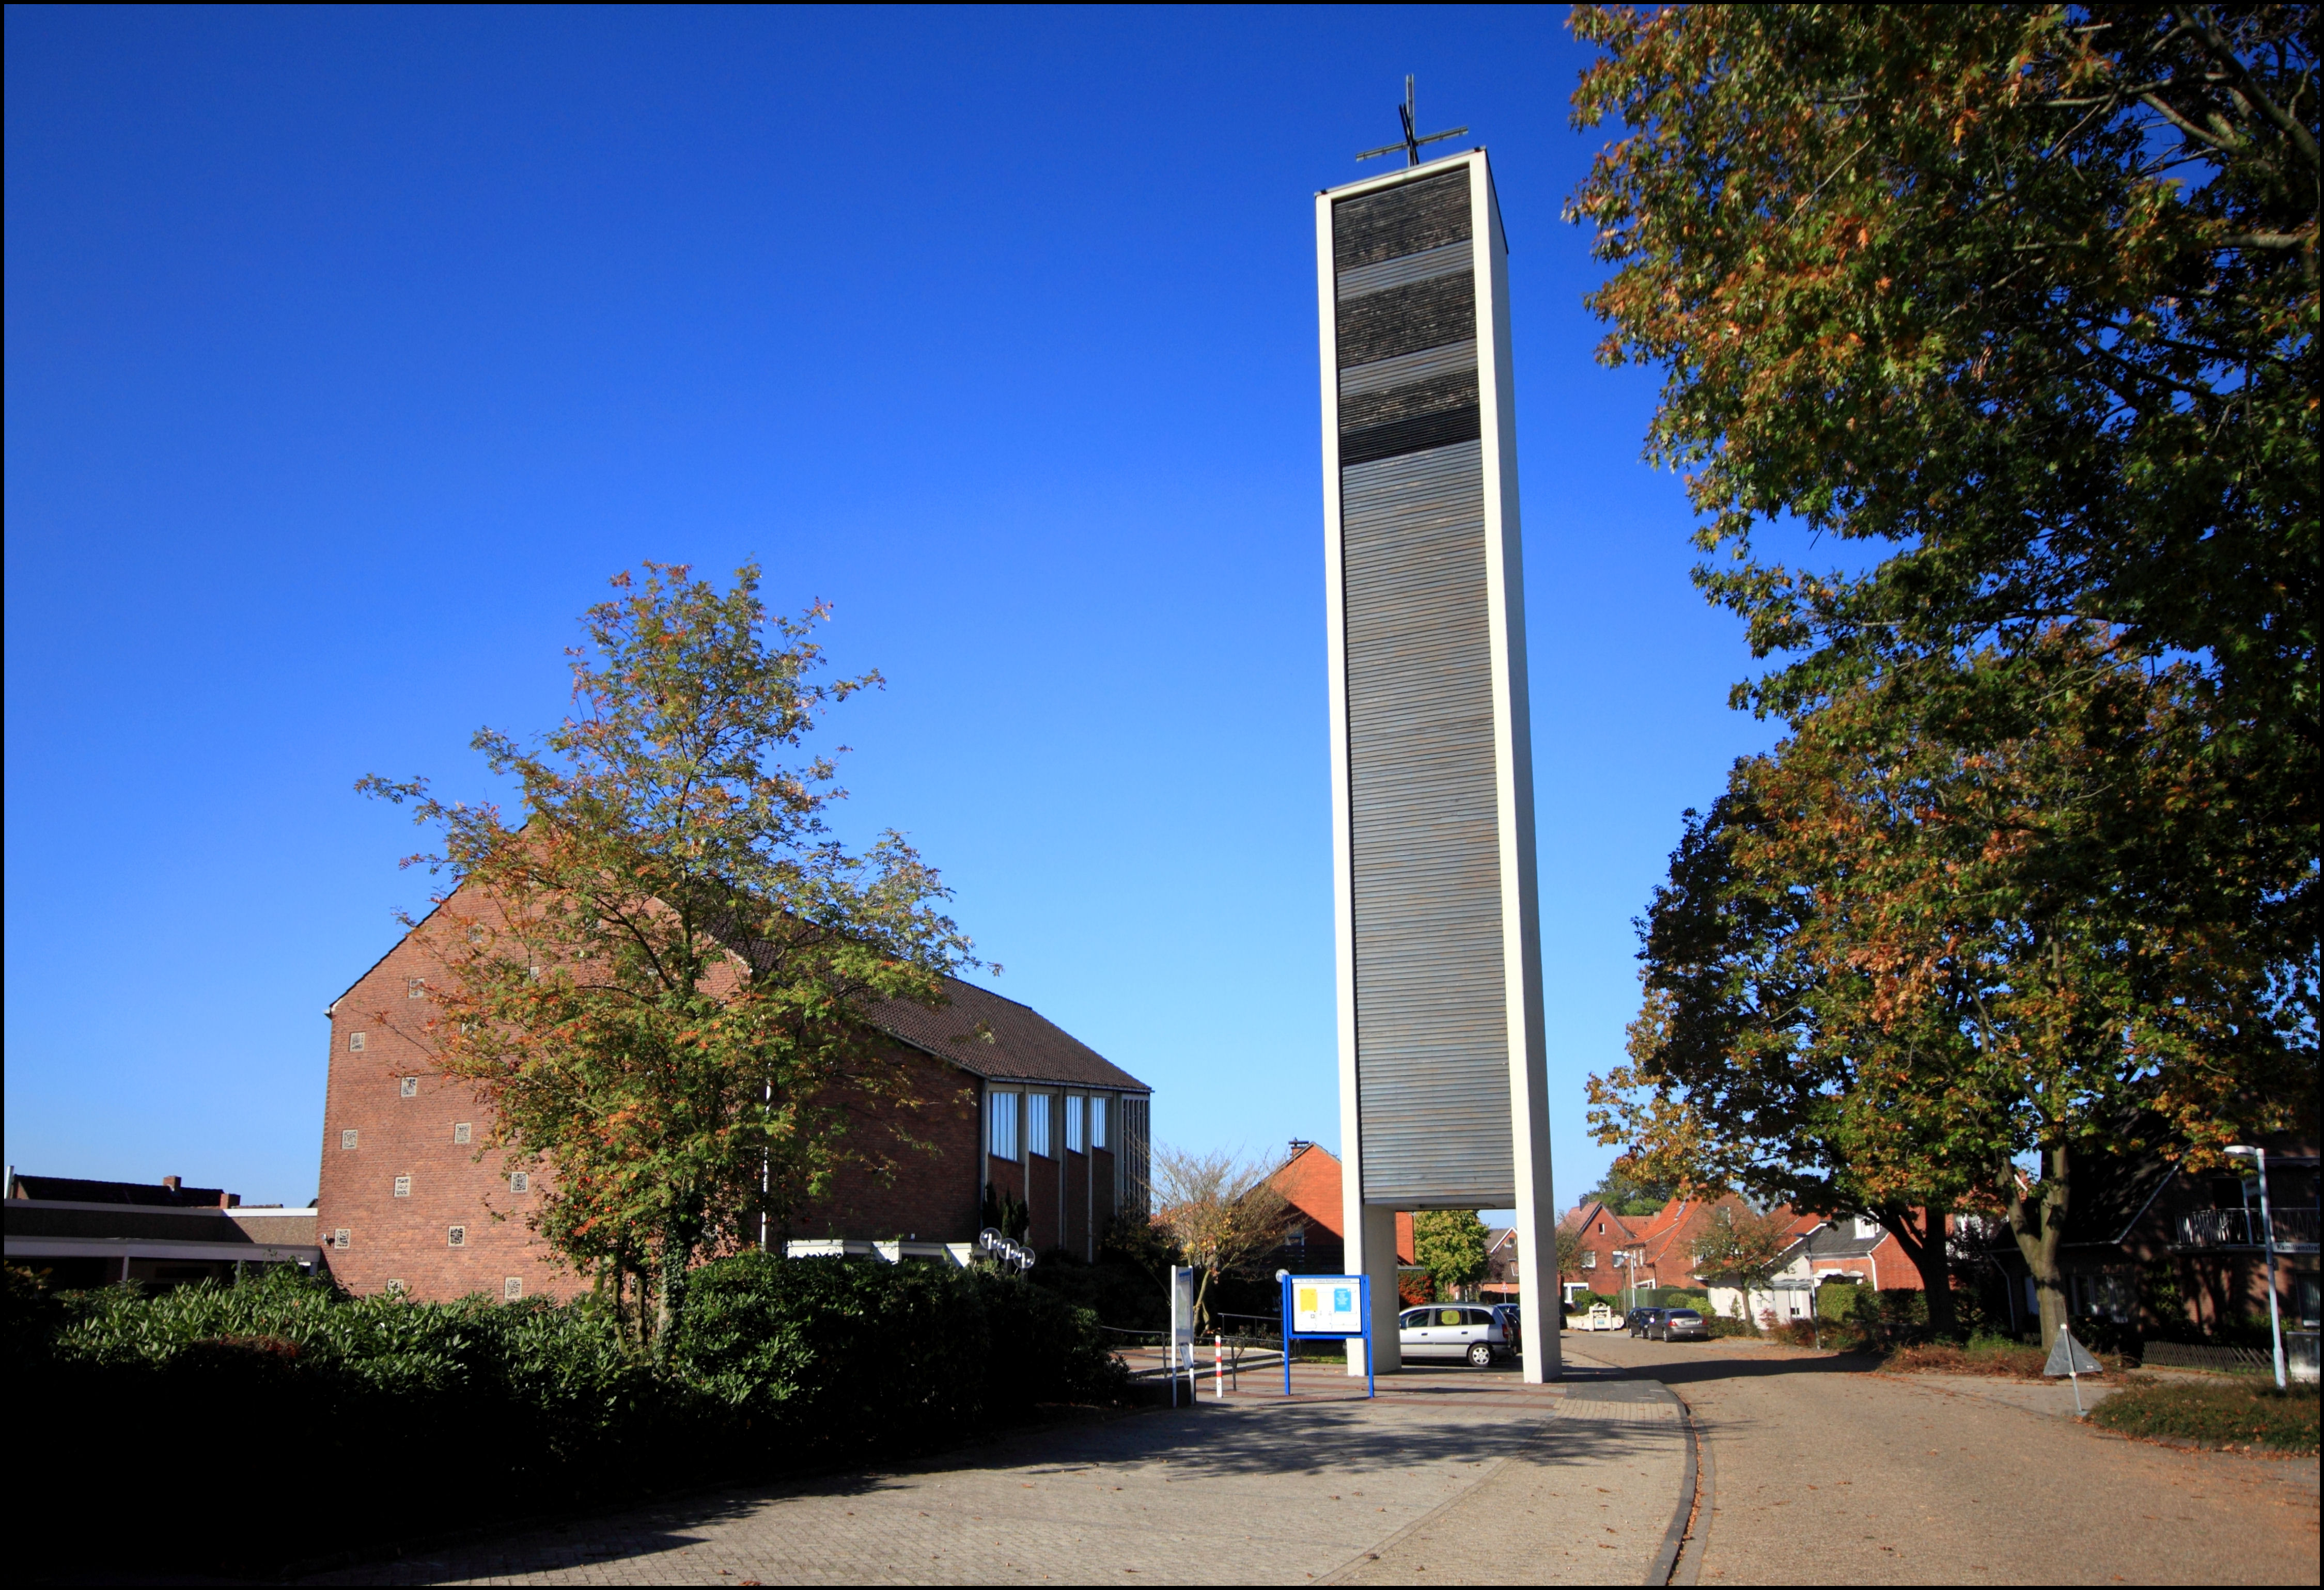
[7,1253,1122,1571]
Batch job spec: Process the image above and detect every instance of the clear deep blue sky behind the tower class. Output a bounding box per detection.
[5,7,1771,1202]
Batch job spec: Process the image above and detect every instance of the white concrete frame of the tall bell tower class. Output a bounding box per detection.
[1315,149,1562,1383]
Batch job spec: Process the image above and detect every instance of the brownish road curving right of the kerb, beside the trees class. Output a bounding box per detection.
[1569,1336,2317,1585]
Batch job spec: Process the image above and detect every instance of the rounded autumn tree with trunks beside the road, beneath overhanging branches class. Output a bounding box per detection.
[1592,635,2315,1332]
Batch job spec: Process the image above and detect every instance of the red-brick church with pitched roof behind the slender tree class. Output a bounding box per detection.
[316,888,1150,1299]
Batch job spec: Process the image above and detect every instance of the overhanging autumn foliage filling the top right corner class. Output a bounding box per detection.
[1569,5,2319,758]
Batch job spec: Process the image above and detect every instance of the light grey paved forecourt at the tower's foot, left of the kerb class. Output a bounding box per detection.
[314,1367,1692,1585]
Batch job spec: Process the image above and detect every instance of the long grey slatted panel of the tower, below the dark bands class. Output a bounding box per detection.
[1341,434,1515,1209]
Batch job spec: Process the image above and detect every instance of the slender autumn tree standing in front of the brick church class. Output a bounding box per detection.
[358,562,969,1341]
